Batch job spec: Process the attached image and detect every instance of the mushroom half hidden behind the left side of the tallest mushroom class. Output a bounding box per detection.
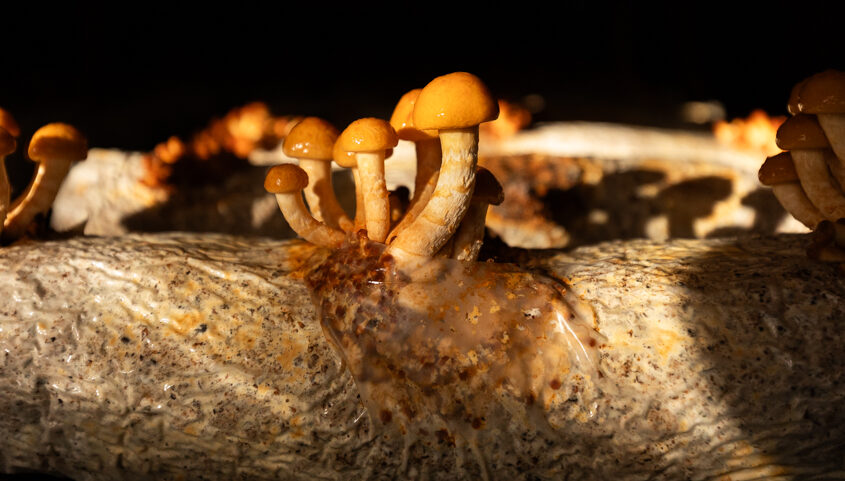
[387,89,442,243]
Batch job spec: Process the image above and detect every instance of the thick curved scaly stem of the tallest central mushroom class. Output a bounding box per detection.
[390,125,478,257]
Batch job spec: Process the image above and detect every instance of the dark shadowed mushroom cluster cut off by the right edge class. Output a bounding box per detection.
[758,70,845,262]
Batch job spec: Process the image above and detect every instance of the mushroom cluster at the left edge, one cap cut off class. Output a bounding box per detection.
[0,109,88,241]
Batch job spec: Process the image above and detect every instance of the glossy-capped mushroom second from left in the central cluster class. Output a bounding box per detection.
[283,117,352,232]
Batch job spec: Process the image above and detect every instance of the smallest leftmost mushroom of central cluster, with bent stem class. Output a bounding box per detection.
[264,164,345,248]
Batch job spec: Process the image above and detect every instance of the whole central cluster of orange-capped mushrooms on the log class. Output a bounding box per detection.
[264,72,503,262]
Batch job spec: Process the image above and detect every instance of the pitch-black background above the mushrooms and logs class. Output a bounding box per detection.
[0,1,845,150]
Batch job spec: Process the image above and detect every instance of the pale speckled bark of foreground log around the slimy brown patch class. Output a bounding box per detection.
[0,234,845,480]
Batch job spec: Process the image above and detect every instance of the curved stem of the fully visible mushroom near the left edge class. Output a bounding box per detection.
[3,161,71,238]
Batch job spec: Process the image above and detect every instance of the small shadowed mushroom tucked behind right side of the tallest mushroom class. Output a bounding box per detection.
[451,167,505,262]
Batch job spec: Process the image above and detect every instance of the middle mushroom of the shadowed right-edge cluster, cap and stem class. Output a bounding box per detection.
[777,112,845,220]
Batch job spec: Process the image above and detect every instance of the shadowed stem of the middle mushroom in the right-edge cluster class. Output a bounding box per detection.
[791,149,845,221]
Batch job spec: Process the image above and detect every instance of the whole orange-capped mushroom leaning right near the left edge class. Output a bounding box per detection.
[3,123,88,238]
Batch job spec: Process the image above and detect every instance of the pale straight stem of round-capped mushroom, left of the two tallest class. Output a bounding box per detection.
[357,151,390,242]
